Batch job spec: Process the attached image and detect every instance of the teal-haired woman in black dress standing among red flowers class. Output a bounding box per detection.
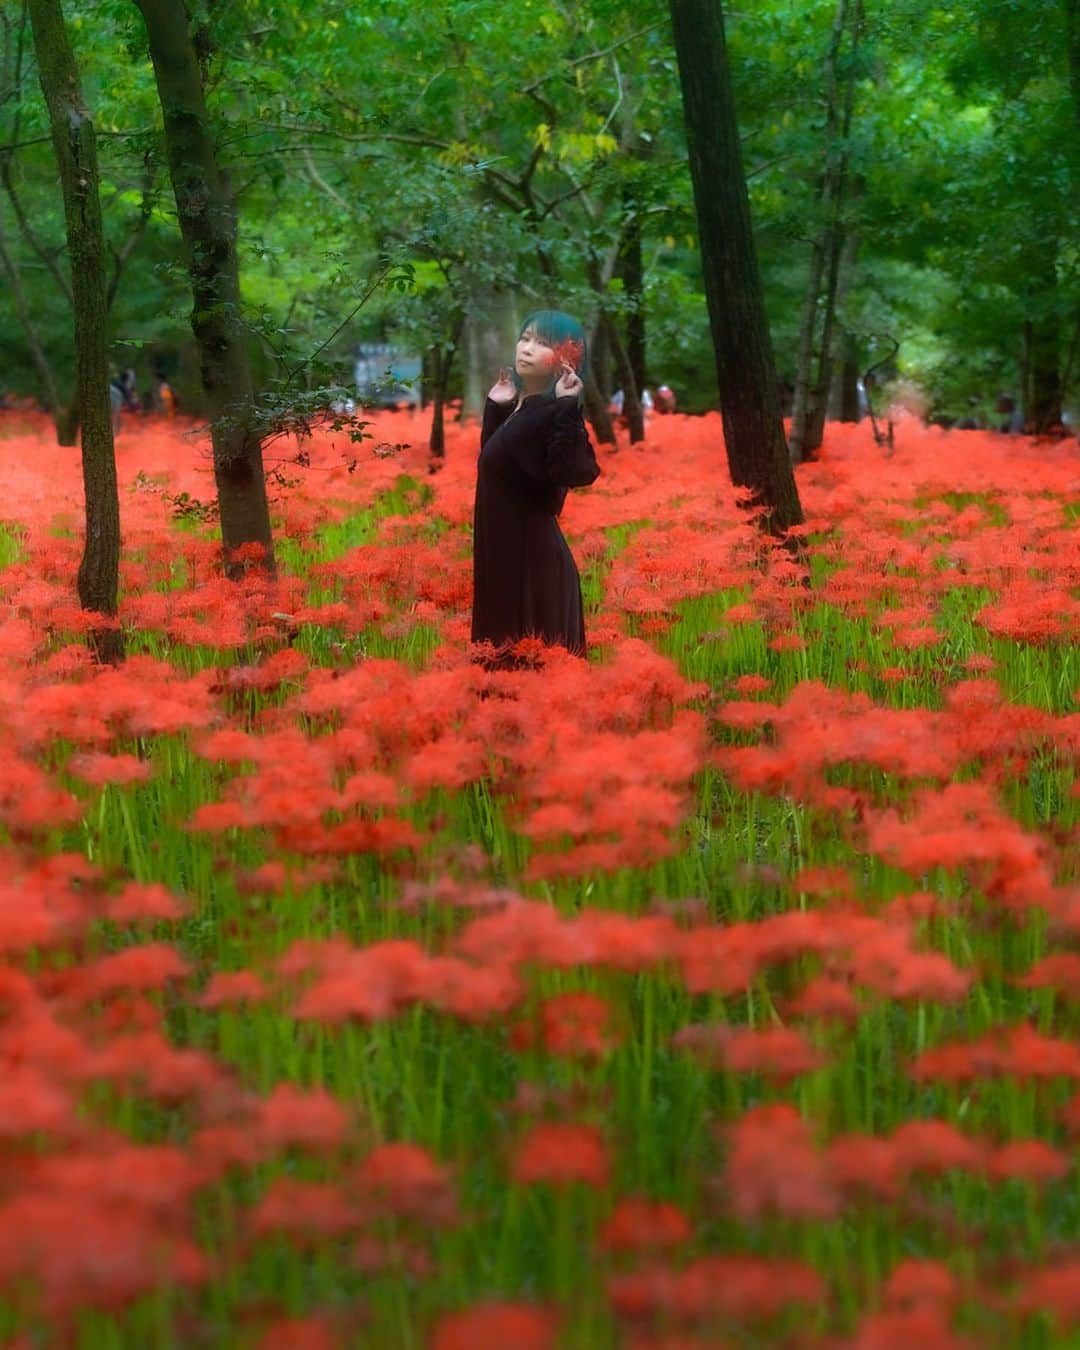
[473,309,599,666]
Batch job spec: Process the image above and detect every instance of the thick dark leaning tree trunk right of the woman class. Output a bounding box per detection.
[670,0,803,533]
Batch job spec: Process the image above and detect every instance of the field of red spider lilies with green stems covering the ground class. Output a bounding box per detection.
[0,413,1080,1350]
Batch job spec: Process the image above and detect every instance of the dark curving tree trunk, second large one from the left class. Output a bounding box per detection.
[135,0,274,579]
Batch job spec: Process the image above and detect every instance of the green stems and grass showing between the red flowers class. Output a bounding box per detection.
[0,478,1080,1350]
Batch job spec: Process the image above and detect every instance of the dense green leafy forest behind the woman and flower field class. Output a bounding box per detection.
[0,0,1080,427]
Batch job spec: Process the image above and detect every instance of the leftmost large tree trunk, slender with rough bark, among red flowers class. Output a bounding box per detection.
[30,0,124,662]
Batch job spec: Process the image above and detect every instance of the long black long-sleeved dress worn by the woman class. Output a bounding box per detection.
[473,394,599,656]
